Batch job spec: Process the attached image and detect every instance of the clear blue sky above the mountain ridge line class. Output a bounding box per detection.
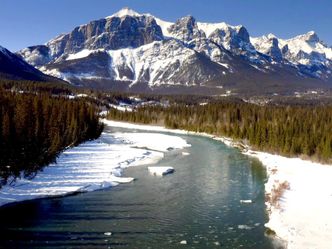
[0,0,332,51]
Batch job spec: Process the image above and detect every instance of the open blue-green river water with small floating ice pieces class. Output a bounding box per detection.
[0,129,275,249]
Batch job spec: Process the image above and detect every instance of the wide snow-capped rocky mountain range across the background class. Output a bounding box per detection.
[17,8,332,94]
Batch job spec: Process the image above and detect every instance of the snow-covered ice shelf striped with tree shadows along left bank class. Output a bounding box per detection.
[0,129,190,206]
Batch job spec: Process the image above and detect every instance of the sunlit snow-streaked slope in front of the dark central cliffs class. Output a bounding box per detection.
[109,40,220,86]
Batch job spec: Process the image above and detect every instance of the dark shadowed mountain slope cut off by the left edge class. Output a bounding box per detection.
[0,46,57,81]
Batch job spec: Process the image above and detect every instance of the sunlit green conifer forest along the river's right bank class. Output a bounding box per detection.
[108,100,332,163]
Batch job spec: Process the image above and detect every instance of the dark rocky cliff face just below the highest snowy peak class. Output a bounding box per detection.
[27,16,163,60]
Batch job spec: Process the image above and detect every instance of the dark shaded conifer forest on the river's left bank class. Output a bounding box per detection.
[0,83,103,186]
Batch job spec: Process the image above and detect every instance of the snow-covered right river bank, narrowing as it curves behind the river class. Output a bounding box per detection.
[103,120,332,249]
